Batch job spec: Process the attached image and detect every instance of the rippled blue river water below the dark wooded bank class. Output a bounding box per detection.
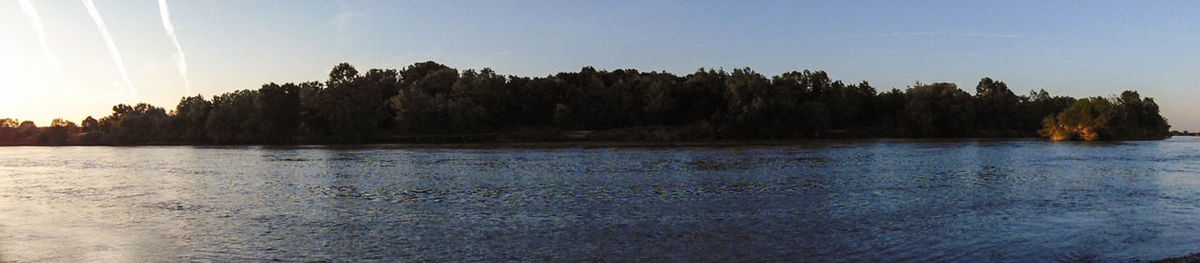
[0,137,1200,262]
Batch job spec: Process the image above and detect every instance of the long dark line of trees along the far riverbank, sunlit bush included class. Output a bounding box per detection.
[0,61,1170,145]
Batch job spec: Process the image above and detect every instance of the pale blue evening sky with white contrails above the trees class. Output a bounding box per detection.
[0,0,1200,131]
